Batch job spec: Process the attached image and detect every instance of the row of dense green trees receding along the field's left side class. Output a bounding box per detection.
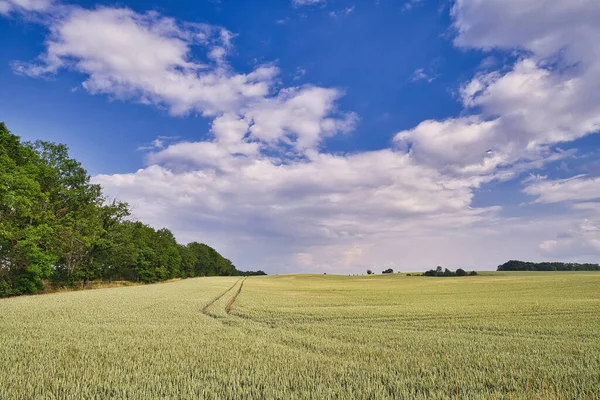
[0,123,265,297]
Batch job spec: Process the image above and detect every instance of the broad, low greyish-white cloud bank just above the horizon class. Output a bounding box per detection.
[95,148,506,271]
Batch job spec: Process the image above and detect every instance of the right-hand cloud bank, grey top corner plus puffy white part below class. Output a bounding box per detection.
[395,0,600,186]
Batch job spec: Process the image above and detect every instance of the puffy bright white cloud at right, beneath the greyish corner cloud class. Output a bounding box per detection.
[395,59,600,177]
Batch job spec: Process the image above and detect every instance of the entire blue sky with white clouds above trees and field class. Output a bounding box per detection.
[0,0,600,273]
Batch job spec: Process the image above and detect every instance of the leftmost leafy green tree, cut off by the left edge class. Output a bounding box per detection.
[0,123,57,296]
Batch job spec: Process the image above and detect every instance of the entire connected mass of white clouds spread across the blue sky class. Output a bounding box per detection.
[7,0,600,272]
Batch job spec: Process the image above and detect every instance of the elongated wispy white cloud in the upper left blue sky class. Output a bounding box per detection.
[14,8,278,115]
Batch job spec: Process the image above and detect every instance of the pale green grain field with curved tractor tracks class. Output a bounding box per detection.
[0,272,600,399]
